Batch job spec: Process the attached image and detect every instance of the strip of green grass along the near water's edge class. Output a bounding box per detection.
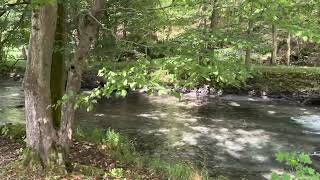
[76,129,209,180]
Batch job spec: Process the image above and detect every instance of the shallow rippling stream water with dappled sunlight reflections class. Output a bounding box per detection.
[0,82,320,179]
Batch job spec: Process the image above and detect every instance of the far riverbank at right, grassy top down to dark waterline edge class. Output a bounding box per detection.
[225,66,320,105]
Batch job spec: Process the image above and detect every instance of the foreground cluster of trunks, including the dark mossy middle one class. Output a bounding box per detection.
[24,0,104,168]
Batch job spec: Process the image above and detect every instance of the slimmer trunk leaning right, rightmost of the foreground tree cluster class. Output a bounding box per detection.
[59,0,104,153]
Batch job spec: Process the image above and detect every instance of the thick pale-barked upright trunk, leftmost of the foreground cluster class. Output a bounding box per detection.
[24,3,57,166]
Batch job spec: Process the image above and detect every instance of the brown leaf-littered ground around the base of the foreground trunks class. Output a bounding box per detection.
[0,136,161,179]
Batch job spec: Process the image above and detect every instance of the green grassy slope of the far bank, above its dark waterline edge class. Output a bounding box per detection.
[241,66,320,96]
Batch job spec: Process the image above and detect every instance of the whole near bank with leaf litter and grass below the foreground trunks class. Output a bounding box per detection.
[0,125,208,180]
